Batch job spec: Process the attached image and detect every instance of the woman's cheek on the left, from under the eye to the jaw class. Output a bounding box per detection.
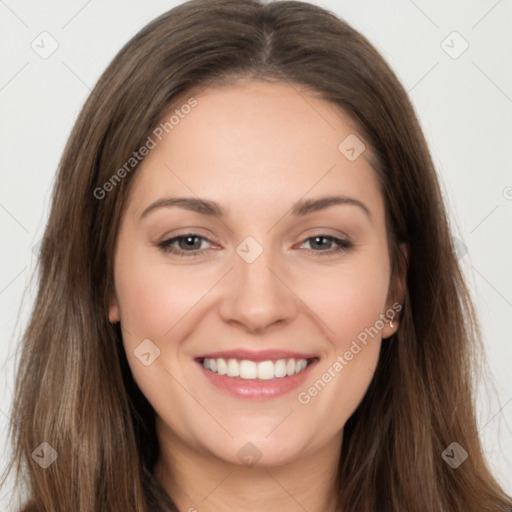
[115,250,202,422]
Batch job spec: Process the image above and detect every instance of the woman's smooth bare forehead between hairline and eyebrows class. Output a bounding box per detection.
[124,80,379,222]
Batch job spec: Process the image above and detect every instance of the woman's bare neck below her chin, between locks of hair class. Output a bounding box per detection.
[154,422,341,512]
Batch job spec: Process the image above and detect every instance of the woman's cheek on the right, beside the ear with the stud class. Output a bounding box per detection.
[297,262,389,430]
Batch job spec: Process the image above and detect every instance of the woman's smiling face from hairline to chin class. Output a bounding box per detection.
[109,81,404,465]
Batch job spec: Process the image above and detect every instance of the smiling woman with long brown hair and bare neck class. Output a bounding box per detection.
[5,0,512,512]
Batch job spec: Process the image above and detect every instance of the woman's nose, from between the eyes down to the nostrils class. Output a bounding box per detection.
[220,243,299,333]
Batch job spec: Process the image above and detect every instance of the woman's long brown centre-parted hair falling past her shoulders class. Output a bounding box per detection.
[5,0,512,512]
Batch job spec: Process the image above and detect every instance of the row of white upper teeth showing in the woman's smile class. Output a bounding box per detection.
[203,357,308,380]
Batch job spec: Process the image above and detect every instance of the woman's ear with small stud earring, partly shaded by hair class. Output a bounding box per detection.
[382,243,409,339]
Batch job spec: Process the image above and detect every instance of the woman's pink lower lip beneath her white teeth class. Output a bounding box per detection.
[198,359,318,400]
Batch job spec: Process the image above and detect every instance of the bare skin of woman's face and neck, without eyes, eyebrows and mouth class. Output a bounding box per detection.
[109,81,403,512]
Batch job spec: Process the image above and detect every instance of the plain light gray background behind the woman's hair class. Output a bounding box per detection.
[0,0,512,510]
